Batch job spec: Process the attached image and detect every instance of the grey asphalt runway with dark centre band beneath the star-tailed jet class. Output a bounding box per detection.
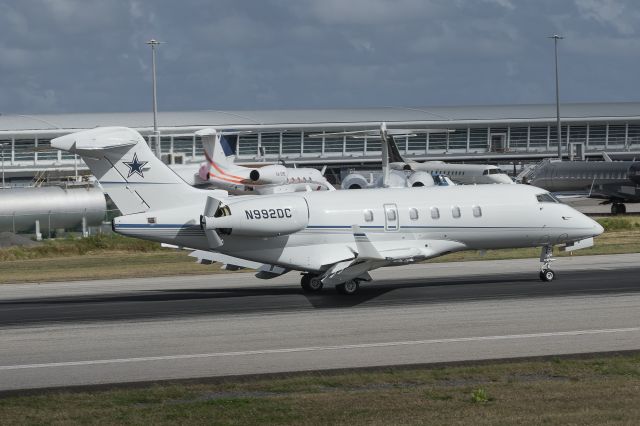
[0,254,640,390]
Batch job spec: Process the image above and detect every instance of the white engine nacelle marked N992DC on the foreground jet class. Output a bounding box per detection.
[201,195,309,237]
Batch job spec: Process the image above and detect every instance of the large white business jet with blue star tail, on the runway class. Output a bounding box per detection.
[51,127,603,294]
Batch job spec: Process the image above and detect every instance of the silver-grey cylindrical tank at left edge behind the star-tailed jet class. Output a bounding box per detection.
[0,186,107,232]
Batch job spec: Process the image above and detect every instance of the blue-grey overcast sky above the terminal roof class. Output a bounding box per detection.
[0,0,640,114]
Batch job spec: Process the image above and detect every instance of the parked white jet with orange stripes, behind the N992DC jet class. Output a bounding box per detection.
[195,128,335,194]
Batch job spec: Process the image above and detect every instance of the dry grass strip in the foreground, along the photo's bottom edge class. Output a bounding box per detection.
[0,353,640,425]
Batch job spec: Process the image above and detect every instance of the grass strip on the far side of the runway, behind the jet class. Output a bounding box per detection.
[0,216,640,284]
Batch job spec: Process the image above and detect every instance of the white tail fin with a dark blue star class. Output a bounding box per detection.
[51,127,208,215]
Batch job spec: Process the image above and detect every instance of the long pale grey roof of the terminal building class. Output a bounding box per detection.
[0,102,640,134]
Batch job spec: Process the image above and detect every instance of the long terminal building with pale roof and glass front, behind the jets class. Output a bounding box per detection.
[0,103,640,184]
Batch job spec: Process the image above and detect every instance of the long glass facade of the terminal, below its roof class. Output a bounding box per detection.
[0,122,640,168]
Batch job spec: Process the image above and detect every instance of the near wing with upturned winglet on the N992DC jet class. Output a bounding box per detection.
[320,225,466,285]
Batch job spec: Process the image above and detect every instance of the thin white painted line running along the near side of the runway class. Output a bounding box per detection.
[0,327,640,371]
